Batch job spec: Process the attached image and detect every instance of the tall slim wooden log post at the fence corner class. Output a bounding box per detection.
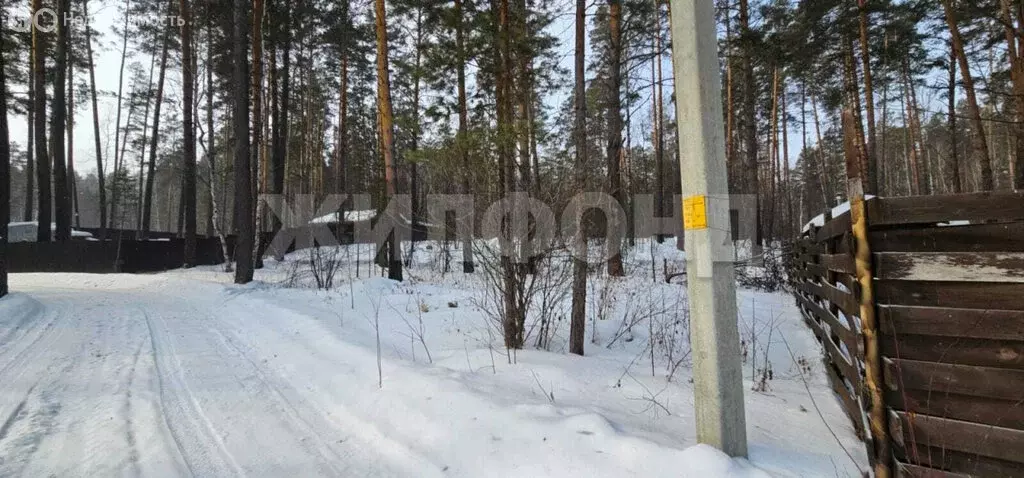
[843,110,892,478]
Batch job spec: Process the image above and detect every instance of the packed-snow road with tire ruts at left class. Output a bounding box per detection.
[0,277,432,476]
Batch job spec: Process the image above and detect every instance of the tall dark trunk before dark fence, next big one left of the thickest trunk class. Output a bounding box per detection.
[178,0,197,267]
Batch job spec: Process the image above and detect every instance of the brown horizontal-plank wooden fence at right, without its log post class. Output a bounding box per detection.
[790,192,1024,477]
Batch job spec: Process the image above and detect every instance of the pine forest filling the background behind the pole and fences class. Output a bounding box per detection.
[0,0,1024,337]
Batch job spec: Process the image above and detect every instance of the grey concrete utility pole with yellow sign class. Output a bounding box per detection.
[671,0,746,457]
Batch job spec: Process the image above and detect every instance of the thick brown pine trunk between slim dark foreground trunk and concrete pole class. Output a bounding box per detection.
[607,0,626,276]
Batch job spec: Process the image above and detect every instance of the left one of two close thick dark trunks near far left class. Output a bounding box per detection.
[32,0,53,243]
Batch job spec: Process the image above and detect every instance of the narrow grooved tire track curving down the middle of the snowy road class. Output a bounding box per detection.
[141,310,245,477]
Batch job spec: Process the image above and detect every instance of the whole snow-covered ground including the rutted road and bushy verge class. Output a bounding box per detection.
[0,242,866,477]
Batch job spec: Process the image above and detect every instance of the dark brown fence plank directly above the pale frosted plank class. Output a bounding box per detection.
[868,222,1024,253]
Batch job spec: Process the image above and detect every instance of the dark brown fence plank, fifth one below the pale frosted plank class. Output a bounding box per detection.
[885,389,1024,430]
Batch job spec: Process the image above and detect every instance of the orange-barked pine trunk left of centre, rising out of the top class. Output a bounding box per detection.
[374,0,402,280]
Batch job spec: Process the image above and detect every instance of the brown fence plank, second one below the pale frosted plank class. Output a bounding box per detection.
[879,305,1024,341]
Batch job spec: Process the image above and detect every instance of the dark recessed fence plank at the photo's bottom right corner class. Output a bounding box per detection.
[893,443,1024,478]
